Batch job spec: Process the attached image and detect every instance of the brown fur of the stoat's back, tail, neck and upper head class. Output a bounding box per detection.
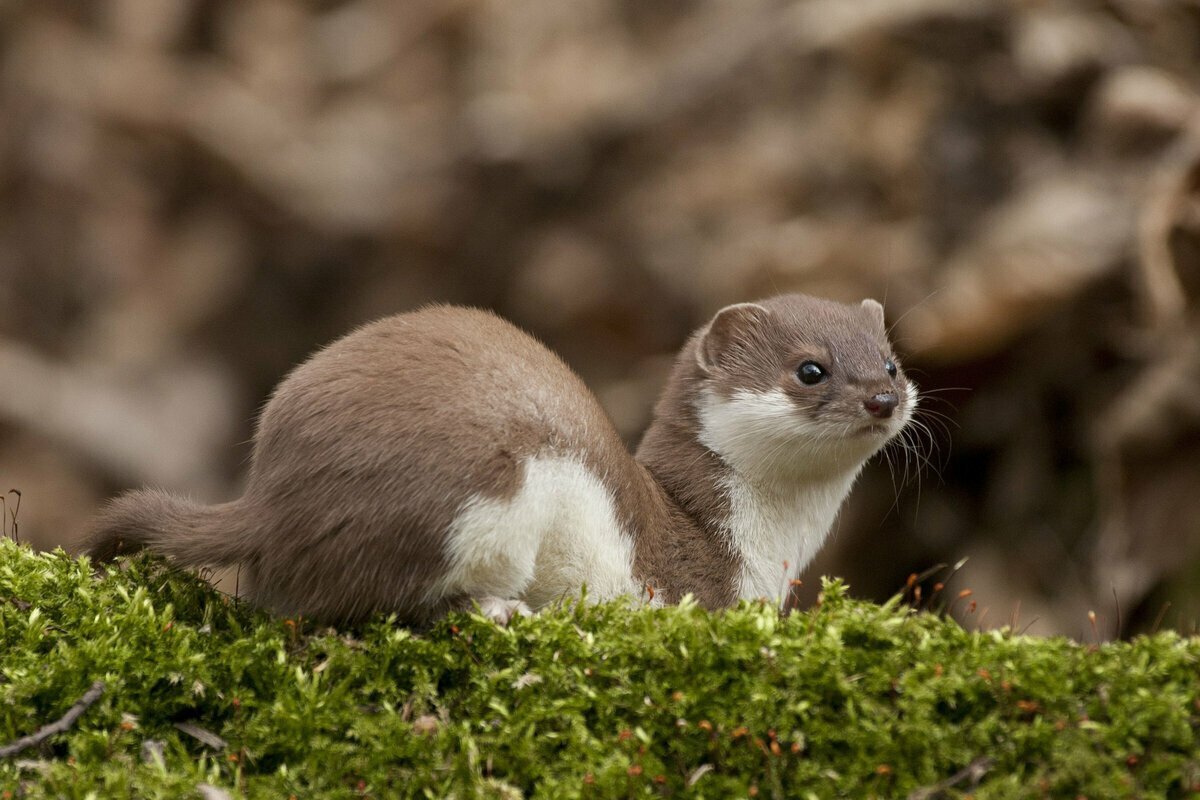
[88,295,907,622]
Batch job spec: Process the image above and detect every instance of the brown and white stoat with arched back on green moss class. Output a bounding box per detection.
[88,294,917,624]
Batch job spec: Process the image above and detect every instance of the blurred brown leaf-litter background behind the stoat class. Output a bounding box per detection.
[0,0,1200,639]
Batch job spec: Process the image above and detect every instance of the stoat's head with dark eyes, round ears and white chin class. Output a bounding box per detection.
[690,294,917,475]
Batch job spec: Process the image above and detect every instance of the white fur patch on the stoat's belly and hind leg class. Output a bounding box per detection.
[430,458,638,609]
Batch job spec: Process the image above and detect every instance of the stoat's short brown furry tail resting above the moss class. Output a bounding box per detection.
[84,489,253,566]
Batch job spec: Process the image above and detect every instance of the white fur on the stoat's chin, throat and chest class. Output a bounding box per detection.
[698,389,916,599]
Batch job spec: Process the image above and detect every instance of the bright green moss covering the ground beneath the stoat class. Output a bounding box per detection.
[0,534,1200,799]
